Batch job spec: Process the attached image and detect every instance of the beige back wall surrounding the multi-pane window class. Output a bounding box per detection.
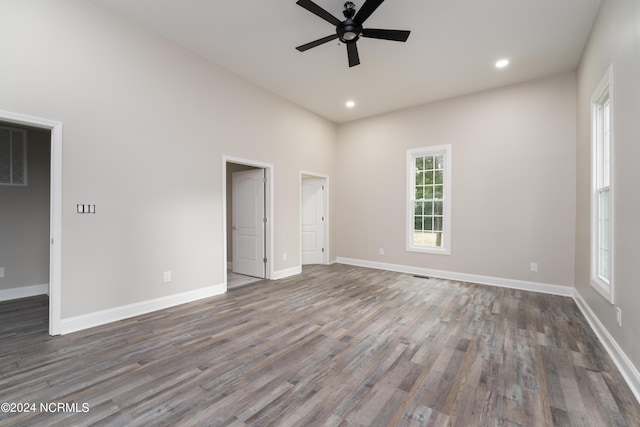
[336,72,576,287]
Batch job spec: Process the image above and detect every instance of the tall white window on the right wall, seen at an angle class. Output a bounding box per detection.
[591,68,613,304]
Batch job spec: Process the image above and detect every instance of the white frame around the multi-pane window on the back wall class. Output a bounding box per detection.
[405,144,452,255]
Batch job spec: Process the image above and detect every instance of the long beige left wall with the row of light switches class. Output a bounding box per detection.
[0,0,336,319]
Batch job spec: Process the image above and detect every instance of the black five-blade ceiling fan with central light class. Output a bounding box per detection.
[296,0,411,67]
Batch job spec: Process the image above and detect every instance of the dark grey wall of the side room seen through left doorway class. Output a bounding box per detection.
[0,123,51,290]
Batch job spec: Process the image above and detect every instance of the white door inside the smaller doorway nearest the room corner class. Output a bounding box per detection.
[301,178,325,265]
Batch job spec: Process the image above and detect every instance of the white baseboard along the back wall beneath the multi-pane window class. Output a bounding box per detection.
[337,257,573,297]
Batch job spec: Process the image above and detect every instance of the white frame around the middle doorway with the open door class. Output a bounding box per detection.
[222,154,274,292]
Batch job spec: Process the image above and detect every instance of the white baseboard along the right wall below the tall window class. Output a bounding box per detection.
[573,289,640,402]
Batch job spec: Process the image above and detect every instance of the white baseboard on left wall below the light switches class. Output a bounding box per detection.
[60,284,227,335]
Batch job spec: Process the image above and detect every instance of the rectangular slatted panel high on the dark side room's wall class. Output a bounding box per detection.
[0,126,27,185]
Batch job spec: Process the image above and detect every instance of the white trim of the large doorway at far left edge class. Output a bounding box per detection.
[0,110,62,335]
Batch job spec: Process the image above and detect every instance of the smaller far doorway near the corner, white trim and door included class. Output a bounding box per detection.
[300,172,329,265]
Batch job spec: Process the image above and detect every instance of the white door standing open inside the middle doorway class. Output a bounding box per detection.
[231,169,266,279]
